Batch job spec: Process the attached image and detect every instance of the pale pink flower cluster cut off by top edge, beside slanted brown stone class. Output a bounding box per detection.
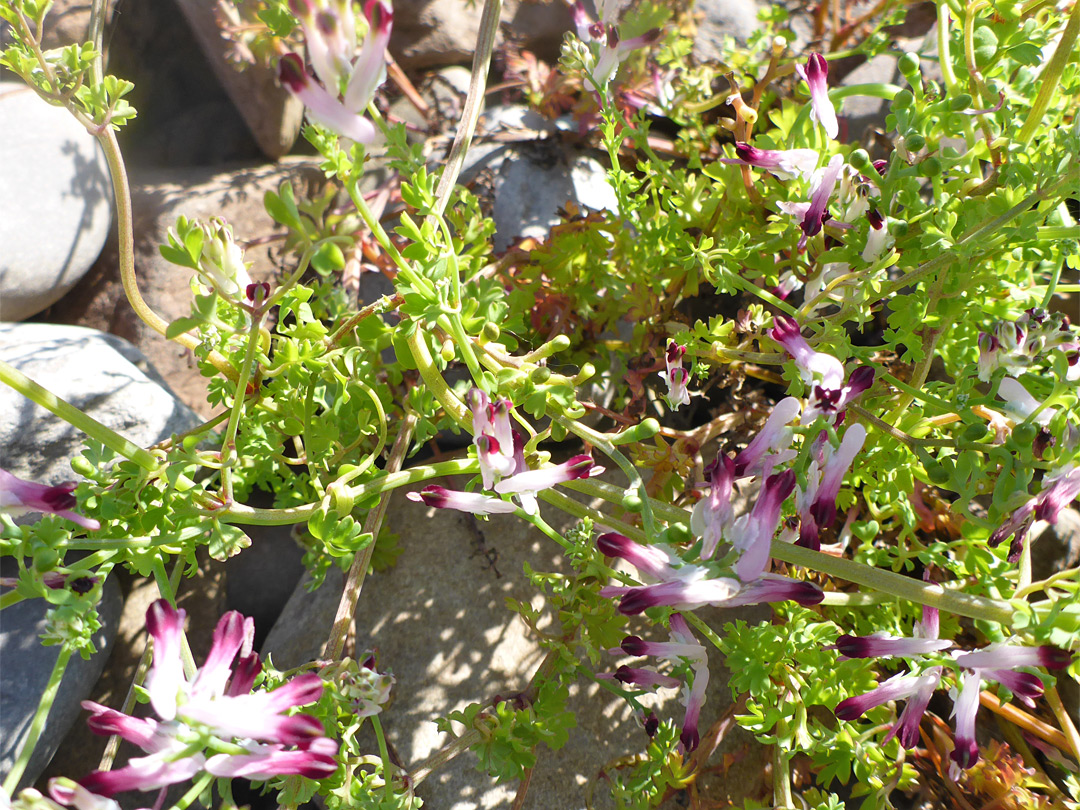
[278,0,393,144]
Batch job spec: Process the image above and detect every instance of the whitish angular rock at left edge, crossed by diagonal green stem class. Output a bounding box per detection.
[0,323,200,484]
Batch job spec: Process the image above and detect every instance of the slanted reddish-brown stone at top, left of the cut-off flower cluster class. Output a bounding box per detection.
[176,0,303,159]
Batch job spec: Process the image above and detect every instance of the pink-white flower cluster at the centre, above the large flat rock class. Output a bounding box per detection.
[406,388,604,515]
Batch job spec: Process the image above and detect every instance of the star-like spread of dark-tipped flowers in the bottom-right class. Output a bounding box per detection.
[835,607,1072,768]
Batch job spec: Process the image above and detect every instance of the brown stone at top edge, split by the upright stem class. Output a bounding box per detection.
[390,0,572,69]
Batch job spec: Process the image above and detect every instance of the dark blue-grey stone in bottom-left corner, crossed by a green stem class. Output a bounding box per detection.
[0,561,122,788]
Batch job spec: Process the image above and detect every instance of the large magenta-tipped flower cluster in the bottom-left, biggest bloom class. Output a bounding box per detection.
[50,599,338,810]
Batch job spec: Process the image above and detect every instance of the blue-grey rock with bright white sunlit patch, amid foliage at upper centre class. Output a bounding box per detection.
[494,140,618,252]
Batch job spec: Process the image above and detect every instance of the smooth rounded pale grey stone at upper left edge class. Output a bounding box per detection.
[0,82,112,321]
